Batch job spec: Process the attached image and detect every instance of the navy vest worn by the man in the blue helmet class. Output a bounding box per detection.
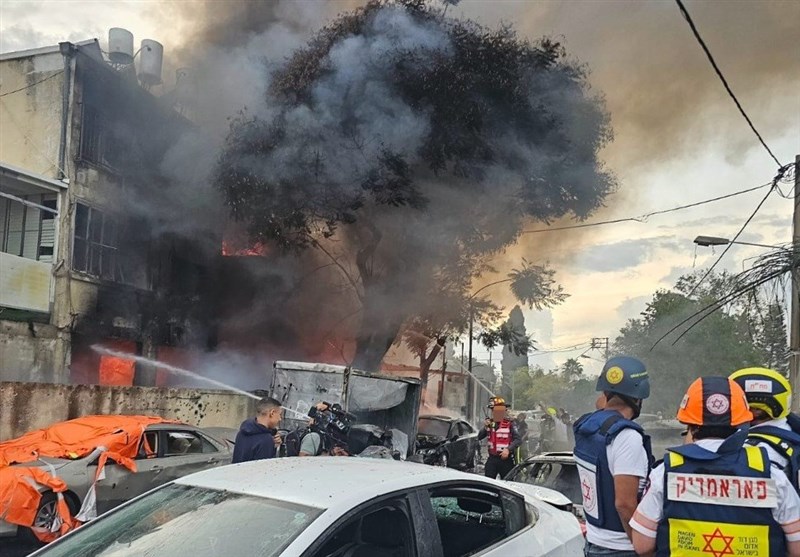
[573,410,653,532]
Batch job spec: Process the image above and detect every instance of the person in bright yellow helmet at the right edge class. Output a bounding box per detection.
[730,367,800,491]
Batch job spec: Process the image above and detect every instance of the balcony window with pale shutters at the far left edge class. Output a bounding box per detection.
[0,194,57,263]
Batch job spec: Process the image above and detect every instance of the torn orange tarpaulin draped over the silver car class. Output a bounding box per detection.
[0,415,175,542]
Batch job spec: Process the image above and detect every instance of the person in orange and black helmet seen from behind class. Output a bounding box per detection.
[630,377,800,557]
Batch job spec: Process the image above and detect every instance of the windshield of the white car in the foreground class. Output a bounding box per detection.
[36,484,324,557]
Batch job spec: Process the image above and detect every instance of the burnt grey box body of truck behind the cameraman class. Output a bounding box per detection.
[268,361,422,460]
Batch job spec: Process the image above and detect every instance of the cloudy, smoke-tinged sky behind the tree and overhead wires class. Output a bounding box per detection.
[0,0,800,371]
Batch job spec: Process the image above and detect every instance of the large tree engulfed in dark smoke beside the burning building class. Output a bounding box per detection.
[217,0,615,369]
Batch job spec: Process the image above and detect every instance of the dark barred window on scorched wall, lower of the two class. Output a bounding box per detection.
[72,203,119,280]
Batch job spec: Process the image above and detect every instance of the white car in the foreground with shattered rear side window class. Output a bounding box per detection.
[29,457,584,557]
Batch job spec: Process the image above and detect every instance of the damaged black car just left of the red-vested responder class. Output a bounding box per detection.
[417,414,480,470]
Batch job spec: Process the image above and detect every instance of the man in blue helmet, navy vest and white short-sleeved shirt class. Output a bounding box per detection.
[573,356,653,557]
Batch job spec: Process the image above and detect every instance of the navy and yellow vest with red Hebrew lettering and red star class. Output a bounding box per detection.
[656,432,786,557]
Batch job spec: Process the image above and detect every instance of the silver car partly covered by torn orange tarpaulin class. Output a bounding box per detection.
[0,415,233,543]
